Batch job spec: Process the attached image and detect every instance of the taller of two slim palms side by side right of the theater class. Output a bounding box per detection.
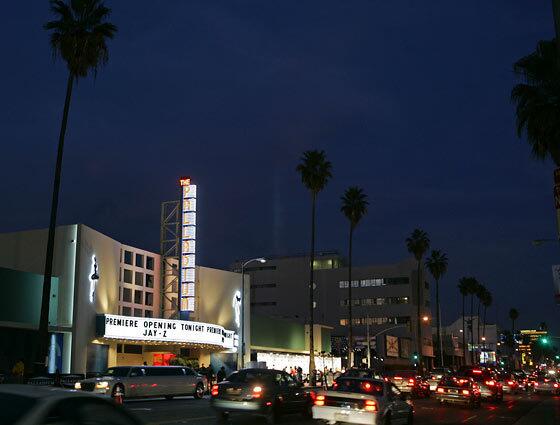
[296,150,332,376]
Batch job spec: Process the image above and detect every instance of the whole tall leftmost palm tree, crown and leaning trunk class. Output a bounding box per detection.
[39,0,117,370]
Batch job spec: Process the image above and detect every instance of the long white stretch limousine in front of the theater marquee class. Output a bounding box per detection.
[74,366,206,399]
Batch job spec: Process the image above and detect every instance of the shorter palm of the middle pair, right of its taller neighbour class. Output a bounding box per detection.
[340,186,368,366]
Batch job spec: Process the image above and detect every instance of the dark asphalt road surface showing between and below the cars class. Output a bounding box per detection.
[125,394,560,425]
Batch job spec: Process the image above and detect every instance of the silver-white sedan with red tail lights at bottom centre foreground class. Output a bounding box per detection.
[312,377,414,425]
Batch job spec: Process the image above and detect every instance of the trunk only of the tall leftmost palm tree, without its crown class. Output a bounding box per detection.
[36,73,74,372]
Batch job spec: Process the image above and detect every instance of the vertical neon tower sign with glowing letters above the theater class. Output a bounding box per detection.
[179,177,196,319]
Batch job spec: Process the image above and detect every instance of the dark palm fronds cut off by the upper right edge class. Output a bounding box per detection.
[511,40,560,167]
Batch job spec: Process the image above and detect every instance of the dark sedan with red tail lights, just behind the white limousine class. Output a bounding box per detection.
[210,369,314,423]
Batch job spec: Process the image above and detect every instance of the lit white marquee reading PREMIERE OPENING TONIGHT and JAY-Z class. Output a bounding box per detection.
[97,314,236,350]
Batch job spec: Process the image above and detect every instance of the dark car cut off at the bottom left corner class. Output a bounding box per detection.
[0,384,141,425]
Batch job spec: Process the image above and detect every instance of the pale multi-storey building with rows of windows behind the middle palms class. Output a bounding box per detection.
[232,252,433,367]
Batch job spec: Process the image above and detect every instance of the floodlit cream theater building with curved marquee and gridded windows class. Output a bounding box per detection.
[0,224,250,373]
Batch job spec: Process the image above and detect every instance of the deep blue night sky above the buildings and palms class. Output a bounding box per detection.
[0,0,560,333]
